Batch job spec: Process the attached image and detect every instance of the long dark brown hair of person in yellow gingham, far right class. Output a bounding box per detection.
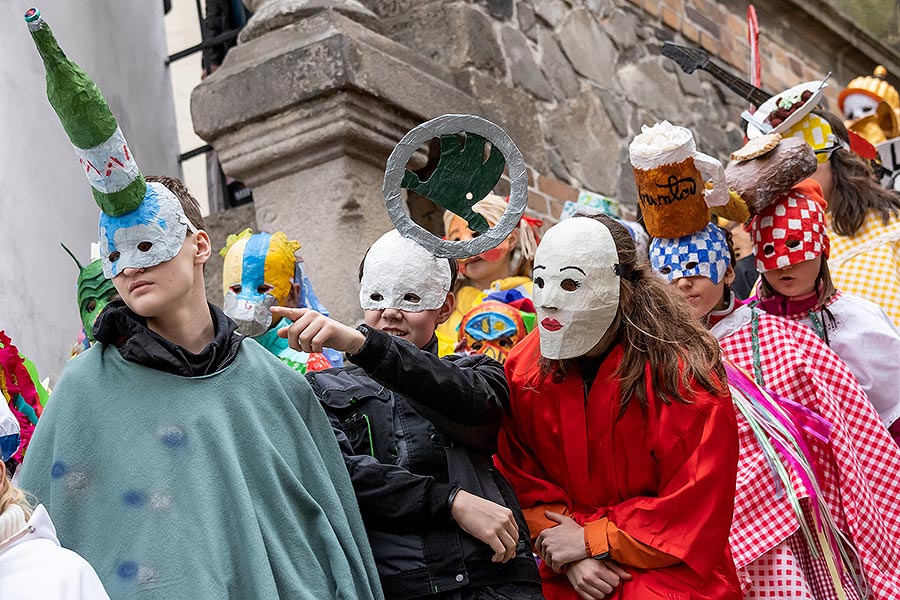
[817,112,900,237]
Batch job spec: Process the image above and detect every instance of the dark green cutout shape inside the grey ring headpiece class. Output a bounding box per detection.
[400,133,506,233]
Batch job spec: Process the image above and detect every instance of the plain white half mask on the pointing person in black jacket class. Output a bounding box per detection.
[359,229,450,312]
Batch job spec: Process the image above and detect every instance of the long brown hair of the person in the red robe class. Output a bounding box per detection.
[541,215,728,414]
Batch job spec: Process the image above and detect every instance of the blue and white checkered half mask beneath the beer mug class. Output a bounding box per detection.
[650,223,731,284]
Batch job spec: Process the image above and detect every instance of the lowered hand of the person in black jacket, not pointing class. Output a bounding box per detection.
[450,490,519,562]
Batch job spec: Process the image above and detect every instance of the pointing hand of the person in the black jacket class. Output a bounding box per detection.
[271,306,366,354]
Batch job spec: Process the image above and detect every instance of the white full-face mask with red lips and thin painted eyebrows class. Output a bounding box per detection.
[533,217,619,360]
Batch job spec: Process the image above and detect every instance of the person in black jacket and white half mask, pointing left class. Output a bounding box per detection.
[272,230,542,600]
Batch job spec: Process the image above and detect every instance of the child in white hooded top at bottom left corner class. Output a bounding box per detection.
[0,462,109,600]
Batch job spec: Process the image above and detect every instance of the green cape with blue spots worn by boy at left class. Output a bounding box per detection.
[21,339,382,600]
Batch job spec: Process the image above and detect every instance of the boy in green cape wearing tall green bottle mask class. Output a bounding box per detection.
[21,9,382,600]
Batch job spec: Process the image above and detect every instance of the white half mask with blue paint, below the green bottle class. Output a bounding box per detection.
[100,182,194,279]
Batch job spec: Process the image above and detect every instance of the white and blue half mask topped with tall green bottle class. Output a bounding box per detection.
[25,8,196,279]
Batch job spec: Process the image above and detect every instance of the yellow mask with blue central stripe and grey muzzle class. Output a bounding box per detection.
[221,229,300,337]
